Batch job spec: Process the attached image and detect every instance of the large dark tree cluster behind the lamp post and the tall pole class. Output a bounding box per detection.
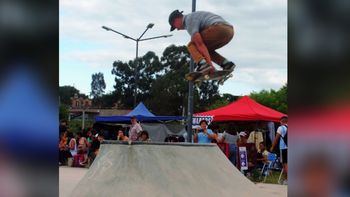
[112,45,220,115]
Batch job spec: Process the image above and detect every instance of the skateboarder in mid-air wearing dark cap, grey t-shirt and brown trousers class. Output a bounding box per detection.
[169,10,235,78]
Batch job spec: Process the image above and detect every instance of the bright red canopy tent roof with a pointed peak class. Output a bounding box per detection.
[194,96,286,122]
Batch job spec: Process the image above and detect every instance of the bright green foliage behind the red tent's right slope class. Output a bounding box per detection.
[250,84,288,114]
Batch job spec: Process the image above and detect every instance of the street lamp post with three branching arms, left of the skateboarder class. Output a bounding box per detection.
[102,23,172,107]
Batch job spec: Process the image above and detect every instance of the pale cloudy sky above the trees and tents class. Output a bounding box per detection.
[59,0,287,95]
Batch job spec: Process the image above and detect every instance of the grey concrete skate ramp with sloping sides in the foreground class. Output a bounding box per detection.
[71,143,271,197]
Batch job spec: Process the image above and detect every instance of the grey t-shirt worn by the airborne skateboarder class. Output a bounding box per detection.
[183,11,231,37]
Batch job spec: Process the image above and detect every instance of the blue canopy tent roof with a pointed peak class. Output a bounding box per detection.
[95,102,185,123]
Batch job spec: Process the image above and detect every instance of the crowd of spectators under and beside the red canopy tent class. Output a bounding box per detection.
[193,116,288,183]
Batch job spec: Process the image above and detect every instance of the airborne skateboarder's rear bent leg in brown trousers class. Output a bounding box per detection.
[201,25,234,66]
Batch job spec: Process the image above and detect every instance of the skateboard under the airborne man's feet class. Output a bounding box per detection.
[186,70,233,86]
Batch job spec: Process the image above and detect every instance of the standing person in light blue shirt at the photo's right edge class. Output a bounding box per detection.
[270,116,288,183]
